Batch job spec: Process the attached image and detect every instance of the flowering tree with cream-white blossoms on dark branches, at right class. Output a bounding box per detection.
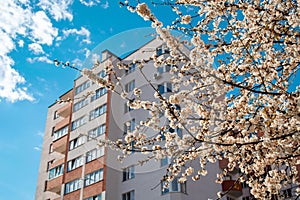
[57,0,300,199]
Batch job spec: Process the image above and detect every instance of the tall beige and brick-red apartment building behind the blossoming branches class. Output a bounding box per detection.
[35,39,272,200]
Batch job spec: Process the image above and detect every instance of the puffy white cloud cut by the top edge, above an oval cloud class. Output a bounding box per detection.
[38,0,73,21]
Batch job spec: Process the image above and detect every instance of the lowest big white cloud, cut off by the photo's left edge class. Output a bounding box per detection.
[0,55,34,103]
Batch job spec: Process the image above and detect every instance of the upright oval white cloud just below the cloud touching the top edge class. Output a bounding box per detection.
[30,11,58,45]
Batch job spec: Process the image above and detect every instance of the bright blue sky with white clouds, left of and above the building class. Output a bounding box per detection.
[0,0,177,200]
